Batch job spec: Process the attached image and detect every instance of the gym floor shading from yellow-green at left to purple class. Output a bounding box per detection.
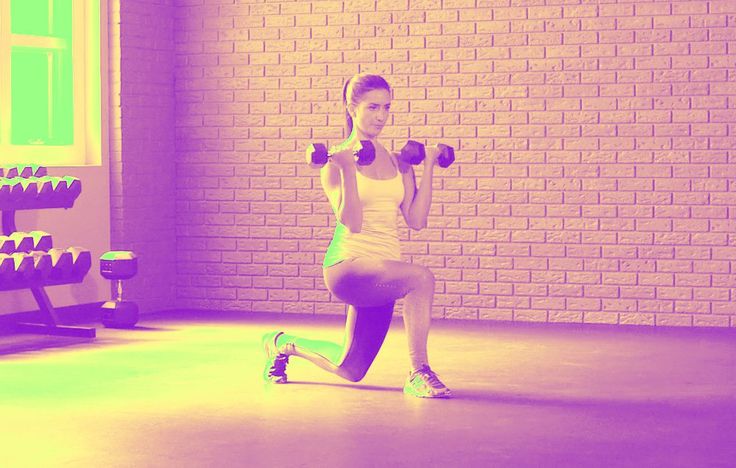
[0,313,736,467]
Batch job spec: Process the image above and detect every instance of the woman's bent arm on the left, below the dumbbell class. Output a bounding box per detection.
[320,150,363,233]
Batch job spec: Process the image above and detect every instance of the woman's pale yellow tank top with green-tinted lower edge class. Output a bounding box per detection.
[322,163,404,268]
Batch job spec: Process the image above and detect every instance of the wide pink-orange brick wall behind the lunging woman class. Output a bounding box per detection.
[174,0,736,327]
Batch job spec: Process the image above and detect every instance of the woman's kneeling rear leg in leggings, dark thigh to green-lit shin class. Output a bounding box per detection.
[278,302,395,382]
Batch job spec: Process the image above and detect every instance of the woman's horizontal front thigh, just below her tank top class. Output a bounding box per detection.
[323,258,434,307]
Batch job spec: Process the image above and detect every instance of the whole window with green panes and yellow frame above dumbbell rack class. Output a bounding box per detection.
[0,0,101,166]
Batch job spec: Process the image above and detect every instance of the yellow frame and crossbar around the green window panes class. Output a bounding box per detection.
[0,0,102,167]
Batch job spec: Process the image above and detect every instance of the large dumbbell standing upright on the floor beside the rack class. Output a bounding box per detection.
[100,250,138,328]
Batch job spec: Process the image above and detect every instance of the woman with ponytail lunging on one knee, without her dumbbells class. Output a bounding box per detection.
[263,74,450,398]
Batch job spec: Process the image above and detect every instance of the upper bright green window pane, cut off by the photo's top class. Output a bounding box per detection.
[10,0,72,38]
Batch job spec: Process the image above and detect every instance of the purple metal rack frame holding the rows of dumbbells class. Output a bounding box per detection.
[0,170,96,338]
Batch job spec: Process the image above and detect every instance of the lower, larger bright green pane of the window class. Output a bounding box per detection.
[10,47,74,145]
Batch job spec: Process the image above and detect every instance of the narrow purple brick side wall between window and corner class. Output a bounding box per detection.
[110,0,176,313]
